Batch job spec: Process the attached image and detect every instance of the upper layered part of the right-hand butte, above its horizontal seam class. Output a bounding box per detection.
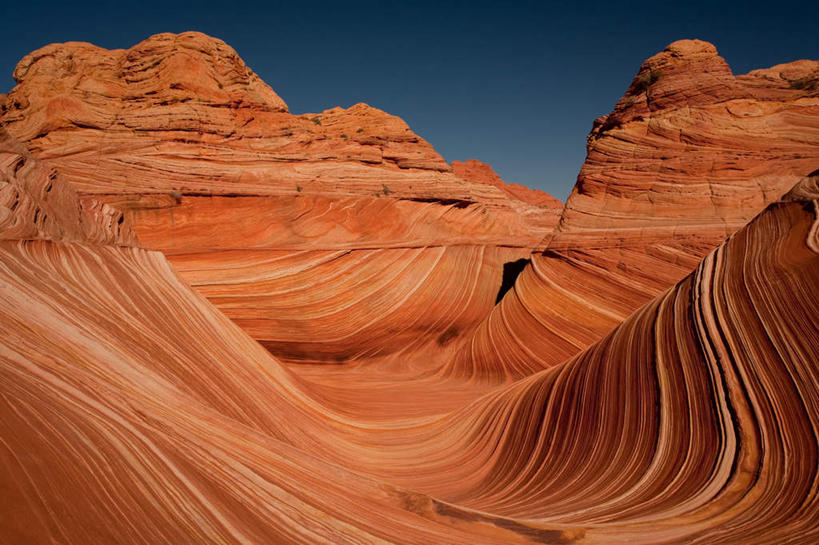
[560,40,819,234]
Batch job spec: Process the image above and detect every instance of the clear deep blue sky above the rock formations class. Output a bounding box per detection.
[0,0,819,199]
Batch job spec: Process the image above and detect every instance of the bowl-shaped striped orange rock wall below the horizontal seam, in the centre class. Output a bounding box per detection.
[170,246,525,364]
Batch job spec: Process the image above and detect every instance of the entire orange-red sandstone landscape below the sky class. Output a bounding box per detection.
[0,33,819,544]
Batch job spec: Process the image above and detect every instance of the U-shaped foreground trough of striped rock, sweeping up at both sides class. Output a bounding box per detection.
[0,130,819,544]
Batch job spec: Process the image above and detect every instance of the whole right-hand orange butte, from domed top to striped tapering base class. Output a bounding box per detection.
[448,40,819,377]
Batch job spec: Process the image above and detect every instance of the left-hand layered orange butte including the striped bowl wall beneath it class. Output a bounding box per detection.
[2,28,557,363]
